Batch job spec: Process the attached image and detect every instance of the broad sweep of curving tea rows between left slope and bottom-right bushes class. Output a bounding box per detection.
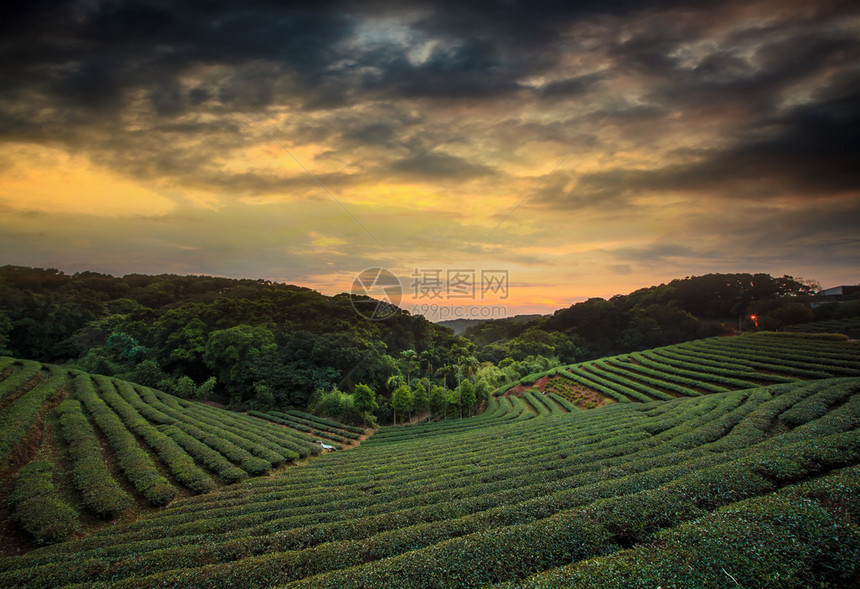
[0,379,860,587]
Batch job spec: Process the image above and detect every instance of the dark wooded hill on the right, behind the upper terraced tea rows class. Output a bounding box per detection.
[465,274,815,363]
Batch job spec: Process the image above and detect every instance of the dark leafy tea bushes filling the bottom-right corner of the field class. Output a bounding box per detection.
[498,467,860,589]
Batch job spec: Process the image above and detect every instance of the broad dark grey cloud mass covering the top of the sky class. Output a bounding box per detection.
[0,0,860,202]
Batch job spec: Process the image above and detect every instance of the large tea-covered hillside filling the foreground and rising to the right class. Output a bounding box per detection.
[0,336,860,588]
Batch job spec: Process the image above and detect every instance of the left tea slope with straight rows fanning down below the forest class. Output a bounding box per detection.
[0,357,364,552]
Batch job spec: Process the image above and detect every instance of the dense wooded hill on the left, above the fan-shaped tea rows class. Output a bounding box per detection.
[0,266,484,409]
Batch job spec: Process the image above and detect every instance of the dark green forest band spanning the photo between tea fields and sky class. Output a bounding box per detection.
[0,266,848,423]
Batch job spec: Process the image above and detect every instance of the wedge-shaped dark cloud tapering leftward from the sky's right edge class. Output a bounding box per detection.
[564,76,860,201]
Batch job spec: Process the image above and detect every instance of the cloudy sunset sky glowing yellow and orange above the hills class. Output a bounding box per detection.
[0,0,860,320]
